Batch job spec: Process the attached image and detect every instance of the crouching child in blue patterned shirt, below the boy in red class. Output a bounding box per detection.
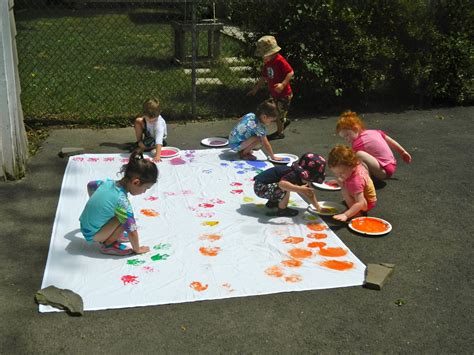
[229,99,282,160]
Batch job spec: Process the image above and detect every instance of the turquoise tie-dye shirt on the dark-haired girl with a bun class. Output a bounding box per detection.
[79,180,137,242]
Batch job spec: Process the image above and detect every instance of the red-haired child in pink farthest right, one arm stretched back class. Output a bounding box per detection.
[336,111,411,180]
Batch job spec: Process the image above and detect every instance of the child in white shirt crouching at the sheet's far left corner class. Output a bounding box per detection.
[134,98,168,162]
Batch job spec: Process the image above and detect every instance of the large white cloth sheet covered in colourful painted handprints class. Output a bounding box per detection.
[40,149,365,312]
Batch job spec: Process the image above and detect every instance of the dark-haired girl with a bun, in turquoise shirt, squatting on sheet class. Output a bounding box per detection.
[79,151,158,255]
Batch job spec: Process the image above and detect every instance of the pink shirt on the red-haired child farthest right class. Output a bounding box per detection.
[352,129,397,168]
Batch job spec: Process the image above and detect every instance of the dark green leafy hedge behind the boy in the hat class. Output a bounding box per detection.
[221,0,474,106]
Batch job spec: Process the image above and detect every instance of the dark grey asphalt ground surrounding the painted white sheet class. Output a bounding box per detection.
[0,107,474,354]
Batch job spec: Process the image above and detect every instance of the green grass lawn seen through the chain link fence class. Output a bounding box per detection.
[15,8,256,127]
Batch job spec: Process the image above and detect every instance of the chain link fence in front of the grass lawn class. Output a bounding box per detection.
[14,0,266,126]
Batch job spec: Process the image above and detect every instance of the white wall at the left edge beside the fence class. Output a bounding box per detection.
[0,0,28,180]
